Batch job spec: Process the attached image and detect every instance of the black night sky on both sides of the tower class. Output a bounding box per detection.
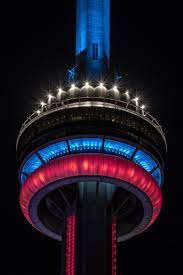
[0,0,183,275]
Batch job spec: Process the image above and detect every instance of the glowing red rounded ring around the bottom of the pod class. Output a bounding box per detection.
[20,154,162,242]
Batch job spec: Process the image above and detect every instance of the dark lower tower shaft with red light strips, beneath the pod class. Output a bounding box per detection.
[62,181,117,275]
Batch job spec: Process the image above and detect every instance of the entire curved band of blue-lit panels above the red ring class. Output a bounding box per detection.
[20,138,162,186]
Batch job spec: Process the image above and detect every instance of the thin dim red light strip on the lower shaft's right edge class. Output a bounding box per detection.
[112,218,117,275]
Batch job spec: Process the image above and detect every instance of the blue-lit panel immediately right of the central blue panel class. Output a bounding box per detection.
[104,139,135,159]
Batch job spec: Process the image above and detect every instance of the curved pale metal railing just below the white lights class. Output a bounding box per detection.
[17,97,167,151]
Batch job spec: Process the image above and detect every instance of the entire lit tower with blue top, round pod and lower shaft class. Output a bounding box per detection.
[17,0,167,275]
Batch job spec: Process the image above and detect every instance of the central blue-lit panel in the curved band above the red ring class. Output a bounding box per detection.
[69,138,103,152]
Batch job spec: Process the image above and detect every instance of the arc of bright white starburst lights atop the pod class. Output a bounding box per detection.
[36,82,146,115]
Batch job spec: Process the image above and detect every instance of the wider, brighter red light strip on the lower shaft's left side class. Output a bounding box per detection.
[66,216,76,275]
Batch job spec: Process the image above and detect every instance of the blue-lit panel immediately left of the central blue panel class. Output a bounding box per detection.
[38,141,68,162]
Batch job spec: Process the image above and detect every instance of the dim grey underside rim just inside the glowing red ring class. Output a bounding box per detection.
[29,176,152,242]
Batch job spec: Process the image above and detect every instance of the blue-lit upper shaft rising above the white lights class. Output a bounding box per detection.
[76,0,110,75]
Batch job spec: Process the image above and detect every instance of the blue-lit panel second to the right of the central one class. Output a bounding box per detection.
[133,150,157,172]
